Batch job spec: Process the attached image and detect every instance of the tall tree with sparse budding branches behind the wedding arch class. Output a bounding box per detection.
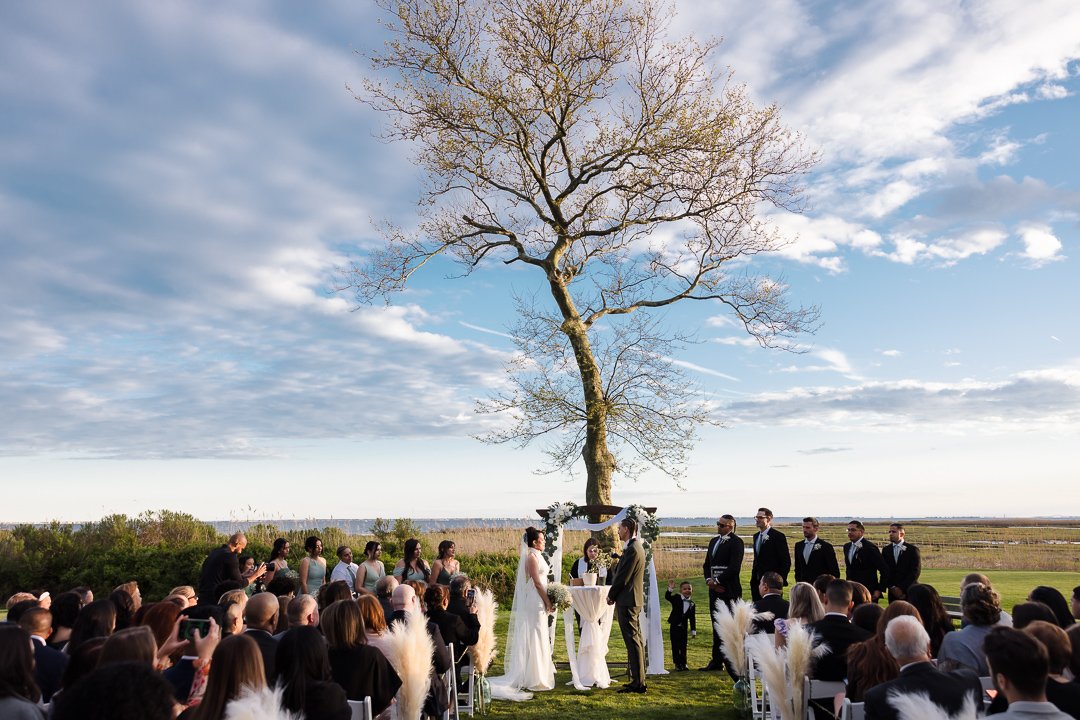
[345,0,818,515]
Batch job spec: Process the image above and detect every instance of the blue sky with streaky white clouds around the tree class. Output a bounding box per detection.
[0,0,1080,520]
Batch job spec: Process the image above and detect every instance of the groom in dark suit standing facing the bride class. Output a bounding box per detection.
[608,518,645,693]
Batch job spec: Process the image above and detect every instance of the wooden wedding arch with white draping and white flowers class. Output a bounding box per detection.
[537,502,667,675]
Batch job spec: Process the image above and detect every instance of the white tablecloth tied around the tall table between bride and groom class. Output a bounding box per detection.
[563,585,615,690]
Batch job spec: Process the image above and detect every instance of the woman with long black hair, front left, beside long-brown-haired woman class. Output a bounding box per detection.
[274,626,352,720]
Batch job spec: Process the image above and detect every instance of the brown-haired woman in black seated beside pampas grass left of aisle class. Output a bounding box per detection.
[322,600,402,715]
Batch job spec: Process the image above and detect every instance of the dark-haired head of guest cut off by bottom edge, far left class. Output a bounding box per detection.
[51,663,176,720]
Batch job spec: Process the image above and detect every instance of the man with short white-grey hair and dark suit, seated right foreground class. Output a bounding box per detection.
[864,615,983,720]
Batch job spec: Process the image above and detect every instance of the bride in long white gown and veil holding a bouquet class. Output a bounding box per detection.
[490,527,555,701]
